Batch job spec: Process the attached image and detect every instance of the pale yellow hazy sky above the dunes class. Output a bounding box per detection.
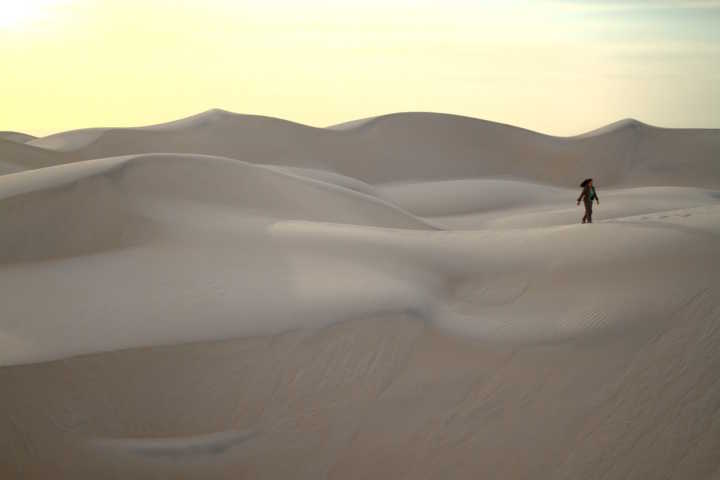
[0,0,720,135]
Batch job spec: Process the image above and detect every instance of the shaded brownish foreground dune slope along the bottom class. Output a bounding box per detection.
[0,280,720,479]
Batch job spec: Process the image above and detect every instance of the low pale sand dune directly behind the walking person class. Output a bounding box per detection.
[376,178,720,229]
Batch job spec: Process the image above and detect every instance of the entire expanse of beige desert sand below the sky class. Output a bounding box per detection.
[0,111,720,479]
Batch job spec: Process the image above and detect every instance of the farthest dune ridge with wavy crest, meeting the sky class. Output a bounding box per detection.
[21,110,720,188]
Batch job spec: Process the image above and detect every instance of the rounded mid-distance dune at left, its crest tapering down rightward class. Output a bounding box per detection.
[0,155,432,263]
